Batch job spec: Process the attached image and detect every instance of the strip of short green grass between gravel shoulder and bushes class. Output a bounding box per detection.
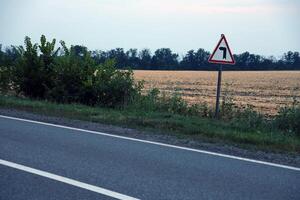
[0,95,300,153]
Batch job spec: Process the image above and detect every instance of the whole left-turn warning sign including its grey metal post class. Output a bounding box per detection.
[208,34,235,118]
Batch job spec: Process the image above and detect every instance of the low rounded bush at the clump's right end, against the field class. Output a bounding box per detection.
[83,60,141,107]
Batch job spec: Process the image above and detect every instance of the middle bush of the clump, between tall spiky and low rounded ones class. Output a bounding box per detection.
[47,41,96,105]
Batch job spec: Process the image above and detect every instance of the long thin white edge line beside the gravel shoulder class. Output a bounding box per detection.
[0,115,300,171]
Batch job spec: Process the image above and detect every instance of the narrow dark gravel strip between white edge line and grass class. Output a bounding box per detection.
[0,108,300,167]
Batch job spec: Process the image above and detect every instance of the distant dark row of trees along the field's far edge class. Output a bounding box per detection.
[0,38,300,70]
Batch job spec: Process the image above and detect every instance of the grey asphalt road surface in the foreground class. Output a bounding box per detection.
[0,116,300,200]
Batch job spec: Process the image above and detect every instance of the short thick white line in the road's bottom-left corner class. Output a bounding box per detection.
[0,159,138,200]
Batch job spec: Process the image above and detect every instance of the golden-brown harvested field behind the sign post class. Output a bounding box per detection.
[134,70,300,115]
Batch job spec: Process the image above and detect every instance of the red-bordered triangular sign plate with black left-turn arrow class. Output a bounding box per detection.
[208,34,235,65]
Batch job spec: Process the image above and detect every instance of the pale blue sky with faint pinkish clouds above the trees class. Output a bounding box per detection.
[0,0,300,57]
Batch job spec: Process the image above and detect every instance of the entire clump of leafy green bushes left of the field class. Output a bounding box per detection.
[0,35,141,107]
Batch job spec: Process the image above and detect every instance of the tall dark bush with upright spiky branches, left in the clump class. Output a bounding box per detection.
[13,35,58,99]
